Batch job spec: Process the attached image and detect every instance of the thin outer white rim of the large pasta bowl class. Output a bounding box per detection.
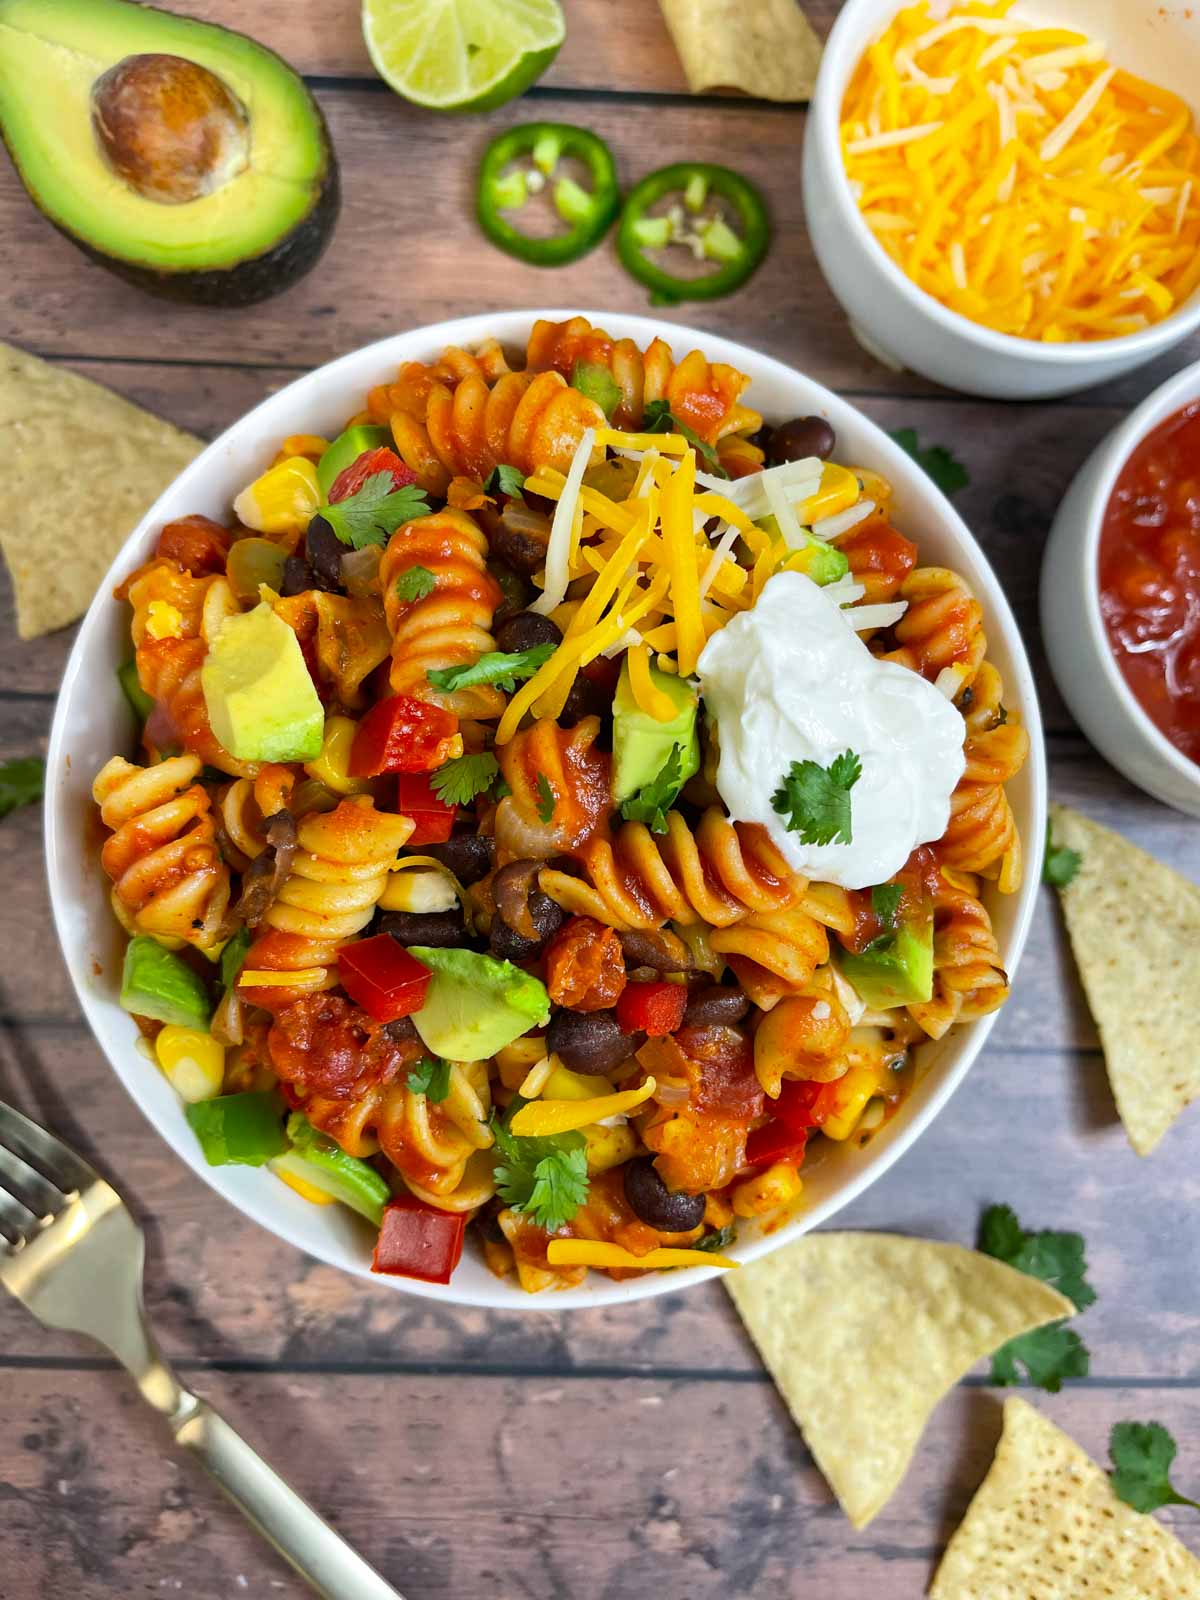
[45,307,1046,1312]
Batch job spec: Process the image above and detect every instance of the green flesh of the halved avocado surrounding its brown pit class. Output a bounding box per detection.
[0,0,336,281]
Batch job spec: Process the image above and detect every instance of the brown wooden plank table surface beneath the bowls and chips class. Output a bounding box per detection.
[0,0,1200,1600]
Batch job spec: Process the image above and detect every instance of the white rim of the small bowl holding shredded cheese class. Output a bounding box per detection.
[805,0,1200,368]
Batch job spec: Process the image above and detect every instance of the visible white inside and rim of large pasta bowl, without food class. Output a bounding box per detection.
[46,310,1046,1310]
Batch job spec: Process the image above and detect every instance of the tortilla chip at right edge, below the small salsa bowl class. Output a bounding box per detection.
[1051,805,1200,1155]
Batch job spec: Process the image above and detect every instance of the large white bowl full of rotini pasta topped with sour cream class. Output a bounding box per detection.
[48,312,1045,1307]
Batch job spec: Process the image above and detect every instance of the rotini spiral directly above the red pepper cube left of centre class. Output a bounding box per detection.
[240,795,413,1011]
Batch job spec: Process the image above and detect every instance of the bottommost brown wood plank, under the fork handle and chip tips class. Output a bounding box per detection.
[0,1371,1200,1600]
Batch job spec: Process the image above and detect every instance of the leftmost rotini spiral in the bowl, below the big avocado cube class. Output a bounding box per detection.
[91,755,229,950]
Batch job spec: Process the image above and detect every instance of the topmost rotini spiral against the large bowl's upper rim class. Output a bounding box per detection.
[526,317,763,448]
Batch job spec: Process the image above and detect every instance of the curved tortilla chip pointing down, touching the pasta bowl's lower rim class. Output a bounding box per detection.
[725,1234,1075,1528]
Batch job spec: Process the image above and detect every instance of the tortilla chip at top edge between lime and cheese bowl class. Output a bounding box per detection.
[659,0,821,101]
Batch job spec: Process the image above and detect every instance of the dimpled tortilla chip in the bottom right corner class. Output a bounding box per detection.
[930,1398,1200,1600]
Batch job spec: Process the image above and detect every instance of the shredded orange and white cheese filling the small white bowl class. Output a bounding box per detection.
[822,0,1200,337]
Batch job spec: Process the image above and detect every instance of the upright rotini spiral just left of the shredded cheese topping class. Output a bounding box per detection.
[379,510,504,717]
